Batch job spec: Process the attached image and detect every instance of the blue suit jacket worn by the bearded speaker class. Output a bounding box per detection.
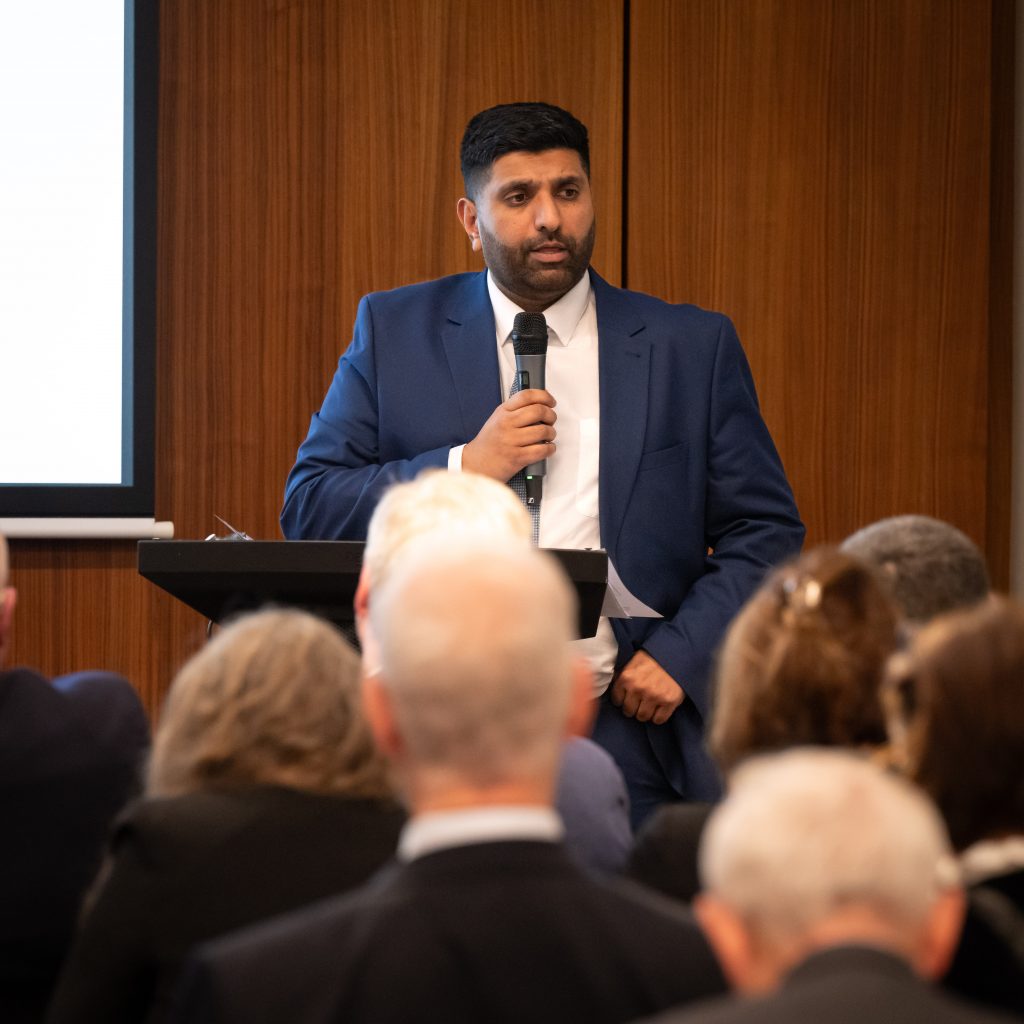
[281,270,804,799]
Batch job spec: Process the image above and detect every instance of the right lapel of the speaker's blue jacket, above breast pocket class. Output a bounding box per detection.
[591,270,650,555]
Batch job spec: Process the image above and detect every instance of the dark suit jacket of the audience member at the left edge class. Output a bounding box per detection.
[0,669,150,1024]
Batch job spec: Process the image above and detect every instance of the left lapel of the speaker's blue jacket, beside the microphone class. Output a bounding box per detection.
[441,272,502,440]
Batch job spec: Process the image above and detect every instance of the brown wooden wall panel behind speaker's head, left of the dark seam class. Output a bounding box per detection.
[11,0,624,709]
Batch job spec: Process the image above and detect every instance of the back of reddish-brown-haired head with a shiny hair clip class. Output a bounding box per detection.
[711,548,897,770]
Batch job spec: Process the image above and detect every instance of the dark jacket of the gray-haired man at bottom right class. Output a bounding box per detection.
[634,946,1013,1024]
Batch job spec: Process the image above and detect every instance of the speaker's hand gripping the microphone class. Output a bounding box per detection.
[462,388,557,483]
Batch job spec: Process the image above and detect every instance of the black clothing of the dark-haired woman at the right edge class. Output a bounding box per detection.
[942,870,1024,1018]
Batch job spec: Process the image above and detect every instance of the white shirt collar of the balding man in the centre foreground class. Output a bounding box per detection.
[398,806,564,860]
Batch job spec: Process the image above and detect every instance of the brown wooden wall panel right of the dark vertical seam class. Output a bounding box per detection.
[627,0,1009,561]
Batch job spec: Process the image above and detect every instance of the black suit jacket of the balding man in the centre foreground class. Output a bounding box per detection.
[169,841,725,1024]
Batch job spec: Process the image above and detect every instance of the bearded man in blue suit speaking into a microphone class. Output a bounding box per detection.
[282,103,804,823]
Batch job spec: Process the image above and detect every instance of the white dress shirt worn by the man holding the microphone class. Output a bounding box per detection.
[449,270,618,696]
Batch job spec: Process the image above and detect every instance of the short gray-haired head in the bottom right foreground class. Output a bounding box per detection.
[699,748,951,947]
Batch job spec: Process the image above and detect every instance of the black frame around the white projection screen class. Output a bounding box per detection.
[0,0,160,519]
